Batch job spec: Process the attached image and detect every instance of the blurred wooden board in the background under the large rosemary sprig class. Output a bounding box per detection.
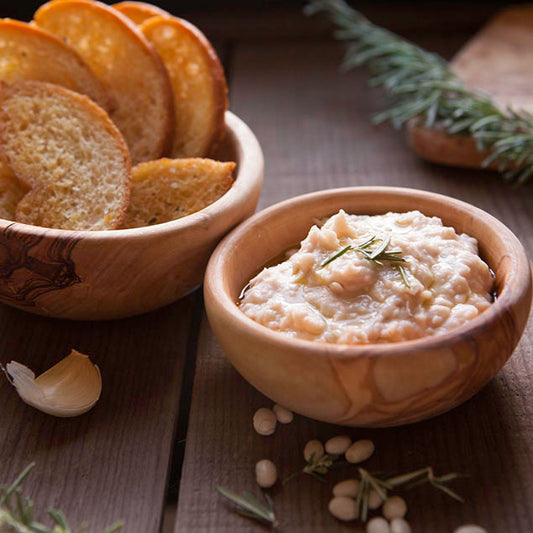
[408,4,533,169]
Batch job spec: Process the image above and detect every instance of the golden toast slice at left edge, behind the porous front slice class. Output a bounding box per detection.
[0,19,112,111]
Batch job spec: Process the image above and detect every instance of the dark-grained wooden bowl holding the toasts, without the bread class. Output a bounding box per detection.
[0,112,264,320]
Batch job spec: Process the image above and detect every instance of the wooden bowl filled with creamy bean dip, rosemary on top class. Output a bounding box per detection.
[204,187,531,427]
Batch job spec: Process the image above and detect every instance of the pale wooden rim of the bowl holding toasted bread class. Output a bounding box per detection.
[0,111,264,241]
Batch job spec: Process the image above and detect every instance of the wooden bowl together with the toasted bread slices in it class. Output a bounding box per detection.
[0,0,264,320]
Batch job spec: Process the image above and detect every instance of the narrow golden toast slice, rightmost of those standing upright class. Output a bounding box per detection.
[141,17,228,158]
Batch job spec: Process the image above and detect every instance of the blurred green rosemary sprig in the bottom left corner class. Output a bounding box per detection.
[0,463,124,533]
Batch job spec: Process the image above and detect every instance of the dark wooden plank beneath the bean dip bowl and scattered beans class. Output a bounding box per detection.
[175,34,533,533]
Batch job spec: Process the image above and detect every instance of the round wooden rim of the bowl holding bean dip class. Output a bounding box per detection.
[204,186,532,358]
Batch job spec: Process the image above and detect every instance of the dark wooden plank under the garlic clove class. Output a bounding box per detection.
[0,295,196,533]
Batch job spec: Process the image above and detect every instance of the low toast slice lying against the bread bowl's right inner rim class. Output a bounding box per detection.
[123,158,235,228]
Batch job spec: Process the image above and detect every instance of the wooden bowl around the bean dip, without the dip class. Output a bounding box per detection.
[204,187,531,427]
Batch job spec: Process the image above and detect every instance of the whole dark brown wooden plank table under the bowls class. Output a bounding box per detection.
[0,3,533,533]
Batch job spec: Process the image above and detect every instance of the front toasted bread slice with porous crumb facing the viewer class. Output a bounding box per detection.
[0,81,131,230]
